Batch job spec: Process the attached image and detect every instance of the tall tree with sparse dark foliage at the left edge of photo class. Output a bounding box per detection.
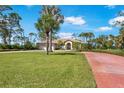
[0,6,21,45]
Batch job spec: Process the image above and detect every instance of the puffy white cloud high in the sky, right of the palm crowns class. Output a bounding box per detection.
[65,16,86,25]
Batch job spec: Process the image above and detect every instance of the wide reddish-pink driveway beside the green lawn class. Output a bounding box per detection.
[85,52,124,88]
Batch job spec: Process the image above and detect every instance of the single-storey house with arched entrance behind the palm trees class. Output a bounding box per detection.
[37,39,82,50]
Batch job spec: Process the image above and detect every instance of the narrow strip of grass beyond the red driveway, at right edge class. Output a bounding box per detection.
[93,49,124,56]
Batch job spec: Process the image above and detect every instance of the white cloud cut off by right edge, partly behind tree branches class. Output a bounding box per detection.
[109,16,124,26]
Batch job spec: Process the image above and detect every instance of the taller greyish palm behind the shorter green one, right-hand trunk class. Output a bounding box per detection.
[42,6,64,52]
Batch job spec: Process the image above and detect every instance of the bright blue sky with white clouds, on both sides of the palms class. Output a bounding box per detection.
[12,5,124,37]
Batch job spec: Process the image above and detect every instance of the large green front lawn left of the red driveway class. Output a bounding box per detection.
[0,52,96,88]
